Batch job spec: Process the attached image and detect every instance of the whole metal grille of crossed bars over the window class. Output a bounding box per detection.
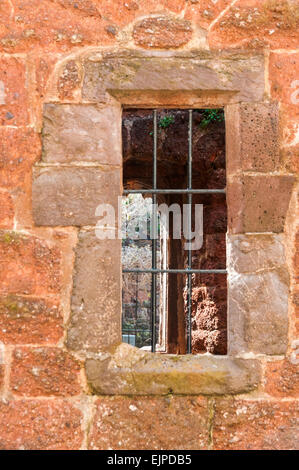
[122,109,227,354]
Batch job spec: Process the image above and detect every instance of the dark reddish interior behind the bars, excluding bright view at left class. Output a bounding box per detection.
[122,109,227,354]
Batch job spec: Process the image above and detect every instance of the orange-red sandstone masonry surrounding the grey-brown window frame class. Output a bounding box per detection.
[0,0,299,449]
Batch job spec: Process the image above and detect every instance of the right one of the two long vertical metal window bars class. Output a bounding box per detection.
[187,109,192,354]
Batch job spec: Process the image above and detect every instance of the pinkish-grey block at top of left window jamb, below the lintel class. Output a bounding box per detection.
[43,104,121,165]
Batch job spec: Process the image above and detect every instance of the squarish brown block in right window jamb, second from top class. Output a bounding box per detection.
[227,175,295,233]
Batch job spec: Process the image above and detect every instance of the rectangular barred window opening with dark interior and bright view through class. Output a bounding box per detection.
[122,109,226,354]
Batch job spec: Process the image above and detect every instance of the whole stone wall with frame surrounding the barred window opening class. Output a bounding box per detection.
[0,0,299,449]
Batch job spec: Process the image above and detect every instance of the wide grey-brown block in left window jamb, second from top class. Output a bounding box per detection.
[32,167,121,226]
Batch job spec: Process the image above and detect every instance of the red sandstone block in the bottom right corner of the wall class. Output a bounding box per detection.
[213,398,299,450]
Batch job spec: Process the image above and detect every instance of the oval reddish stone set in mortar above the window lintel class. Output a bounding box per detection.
[133,16,192,49]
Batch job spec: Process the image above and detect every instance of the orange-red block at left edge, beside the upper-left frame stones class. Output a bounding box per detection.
[0,127,41,189]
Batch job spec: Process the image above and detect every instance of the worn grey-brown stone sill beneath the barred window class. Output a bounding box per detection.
[85,343,261,395]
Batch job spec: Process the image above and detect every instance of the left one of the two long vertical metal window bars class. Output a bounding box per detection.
[151,109,158,352]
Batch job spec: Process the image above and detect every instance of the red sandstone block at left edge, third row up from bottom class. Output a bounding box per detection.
[0,295,63,344]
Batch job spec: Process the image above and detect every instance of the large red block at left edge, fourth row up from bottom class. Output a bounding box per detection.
[0,231,61,295]
